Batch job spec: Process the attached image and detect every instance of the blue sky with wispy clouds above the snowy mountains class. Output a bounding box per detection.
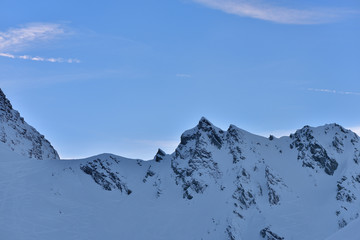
[0,0,360,159]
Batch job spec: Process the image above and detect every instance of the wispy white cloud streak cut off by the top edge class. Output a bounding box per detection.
[193,0,349,24]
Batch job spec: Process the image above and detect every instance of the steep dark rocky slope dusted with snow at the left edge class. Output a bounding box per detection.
[0,89,59,160]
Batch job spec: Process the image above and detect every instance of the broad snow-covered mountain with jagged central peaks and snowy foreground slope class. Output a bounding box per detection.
[0,88,360,240]
